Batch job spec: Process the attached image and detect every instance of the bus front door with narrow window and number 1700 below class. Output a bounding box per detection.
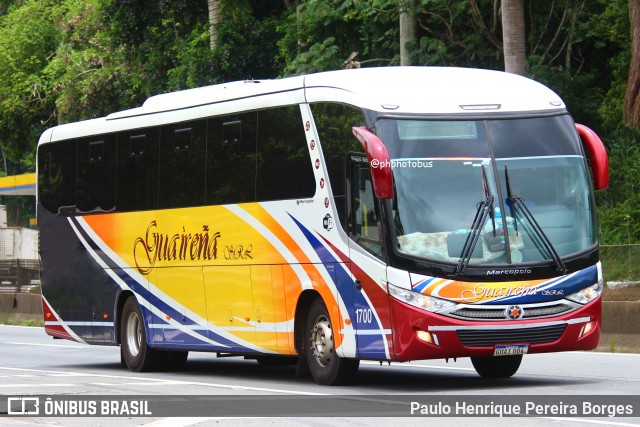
[347,153,391,360]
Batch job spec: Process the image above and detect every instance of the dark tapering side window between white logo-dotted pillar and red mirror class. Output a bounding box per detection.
[311,103,367,230]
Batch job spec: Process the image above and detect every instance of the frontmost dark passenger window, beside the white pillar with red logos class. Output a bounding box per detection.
[256,105,316,201]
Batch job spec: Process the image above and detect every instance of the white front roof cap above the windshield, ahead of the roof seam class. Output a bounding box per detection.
[305,67,565,115]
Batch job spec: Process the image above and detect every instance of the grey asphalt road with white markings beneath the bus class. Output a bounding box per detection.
[0,326,640,426]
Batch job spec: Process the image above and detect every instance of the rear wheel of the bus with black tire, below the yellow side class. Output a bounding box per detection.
[120,295,163,372]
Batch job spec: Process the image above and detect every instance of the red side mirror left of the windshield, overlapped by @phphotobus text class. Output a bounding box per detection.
[351,126,393,199]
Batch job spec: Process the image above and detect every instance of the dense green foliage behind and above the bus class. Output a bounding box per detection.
[0,0,640,247]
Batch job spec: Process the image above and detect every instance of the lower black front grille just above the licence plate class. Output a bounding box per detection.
[457,324,567,347]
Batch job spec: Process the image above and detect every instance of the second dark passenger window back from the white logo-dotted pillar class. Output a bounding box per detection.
[205,111,257,205]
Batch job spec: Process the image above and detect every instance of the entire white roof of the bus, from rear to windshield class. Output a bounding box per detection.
[40,67,565,143]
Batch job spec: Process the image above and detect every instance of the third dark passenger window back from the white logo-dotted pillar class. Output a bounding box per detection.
[159,120,207,209]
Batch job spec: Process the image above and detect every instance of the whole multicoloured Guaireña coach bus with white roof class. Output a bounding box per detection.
[37,67,608,385]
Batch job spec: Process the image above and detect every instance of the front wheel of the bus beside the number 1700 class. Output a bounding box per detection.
[305,297,360,385]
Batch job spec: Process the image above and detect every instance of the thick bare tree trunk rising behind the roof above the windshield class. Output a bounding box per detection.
[502,0,527,76]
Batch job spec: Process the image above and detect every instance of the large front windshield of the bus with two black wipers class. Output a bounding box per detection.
[372,115,597,266]
